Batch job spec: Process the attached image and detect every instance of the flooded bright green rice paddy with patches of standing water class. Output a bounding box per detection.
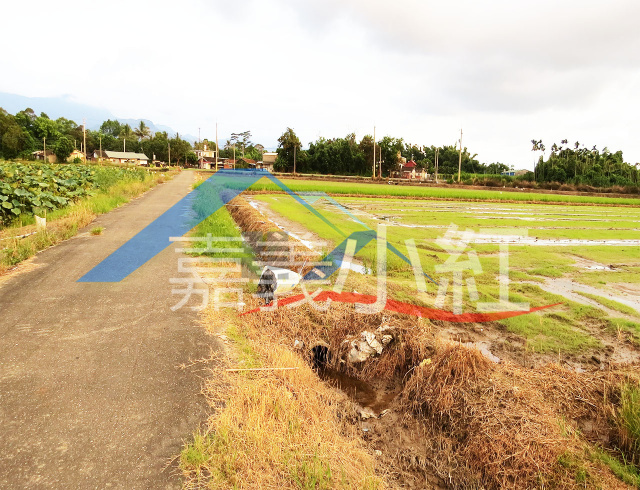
[244,191,640,356]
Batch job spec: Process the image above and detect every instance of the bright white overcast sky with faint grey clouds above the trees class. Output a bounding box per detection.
[0,0,640,169]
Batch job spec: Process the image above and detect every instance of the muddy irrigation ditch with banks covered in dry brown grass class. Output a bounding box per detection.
[212,197,640,489]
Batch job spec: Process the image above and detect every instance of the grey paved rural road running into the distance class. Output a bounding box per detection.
[0,172,216,489]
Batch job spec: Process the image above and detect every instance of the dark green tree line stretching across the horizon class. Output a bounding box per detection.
[0,108,640,187]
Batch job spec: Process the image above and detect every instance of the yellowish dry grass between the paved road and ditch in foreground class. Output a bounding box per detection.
[180,309,385,489]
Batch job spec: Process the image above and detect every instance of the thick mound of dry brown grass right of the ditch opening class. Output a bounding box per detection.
[401,344,636,488]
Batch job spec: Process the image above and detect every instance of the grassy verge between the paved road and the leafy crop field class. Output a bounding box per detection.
[0,173,173,274]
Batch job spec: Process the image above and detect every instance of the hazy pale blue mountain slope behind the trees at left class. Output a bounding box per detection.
[0,92,198,143]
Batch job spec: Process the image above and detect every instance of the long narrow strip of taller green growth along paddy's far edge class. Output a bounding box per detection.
[249,179,640,206]
